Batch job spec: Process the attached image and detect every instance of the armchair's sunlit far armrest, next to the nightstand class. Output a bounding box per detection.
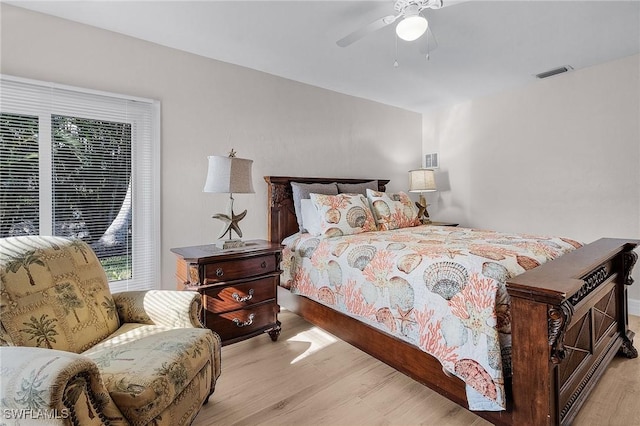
[113,290,203,328]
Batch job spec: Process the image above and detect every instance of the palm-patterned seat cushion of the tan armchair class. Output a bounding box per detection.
[83,323,218,424]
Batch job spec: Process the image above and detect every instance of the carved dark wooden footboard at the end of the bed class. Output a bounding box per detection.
[507,238,638,424]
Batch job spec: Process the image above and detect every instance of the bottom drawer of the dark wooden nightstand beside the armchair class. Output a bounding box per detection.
[205,301,280,342]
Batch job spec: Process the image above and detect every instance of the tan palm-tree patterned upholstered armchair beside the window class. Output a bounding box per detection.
[0,236,221,425]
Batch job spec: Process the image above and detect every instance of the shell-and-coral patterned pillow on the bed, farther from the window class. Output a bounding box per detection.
[367,189,420,231]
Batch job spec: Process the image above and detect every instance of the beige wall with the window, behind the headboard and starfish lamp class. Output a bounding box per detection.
[0,4,422,288]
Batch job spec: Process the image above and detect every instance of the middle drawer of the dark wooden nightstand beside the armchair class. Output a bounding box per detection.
[203,272,280,313]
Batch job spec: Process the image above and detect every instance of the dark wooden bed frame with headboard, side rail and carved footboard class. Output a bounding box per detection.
[265,176,640,425]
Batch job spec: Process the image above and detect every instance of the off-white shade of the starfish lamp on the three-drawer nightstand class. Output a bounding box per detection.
[202,155,255,194]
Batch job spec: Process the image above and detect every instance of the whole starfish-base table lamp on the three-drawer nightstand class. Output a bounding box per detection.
[202,149,255,249]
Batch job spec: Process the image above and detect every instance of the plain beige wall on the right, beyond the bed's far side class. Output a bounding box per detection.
[423,55,640,315]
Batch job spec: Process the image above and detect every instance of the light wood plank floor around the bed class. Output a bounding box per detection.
[193,311,640,426]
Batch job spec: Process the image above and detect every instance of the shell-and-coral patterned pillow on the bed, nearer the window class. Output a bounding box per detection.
[311,194,377,238]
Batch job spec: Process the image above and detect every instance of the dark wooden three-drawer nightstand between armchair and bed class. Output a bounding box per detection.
[171,240,282,345]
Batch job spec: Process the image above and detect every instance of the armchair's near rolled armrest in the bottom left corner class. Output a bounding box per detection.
[0,346,128,425]
